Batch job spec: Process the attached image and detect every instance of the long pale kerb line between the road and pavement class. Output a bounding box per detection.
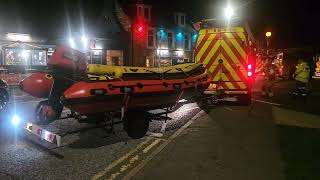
[122,111,204,180]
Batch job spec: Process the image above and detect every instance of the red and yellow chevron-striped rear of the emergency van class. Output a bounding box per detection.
[194,27,247,90]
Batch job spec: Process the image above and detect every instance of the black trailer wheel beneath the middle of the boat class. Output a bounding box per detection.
[123,111,150,139]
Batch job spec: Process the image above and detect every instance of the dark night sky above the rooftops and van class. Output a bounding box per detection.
[0,0,320,48]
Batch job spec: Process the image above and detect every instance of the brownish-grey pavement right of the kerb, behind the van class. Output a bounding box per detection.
[133,104,284,180]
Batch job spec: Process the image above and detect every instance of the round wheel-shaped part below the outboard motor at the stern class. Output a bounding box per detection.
[35,100,63,125]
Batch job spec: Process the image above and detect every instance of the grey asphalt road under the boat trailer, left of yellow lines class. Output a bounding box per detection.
[0,86,200,180]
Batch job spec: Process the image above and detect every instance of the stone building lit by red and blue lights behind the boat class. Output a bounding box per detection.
[120,2,197,67]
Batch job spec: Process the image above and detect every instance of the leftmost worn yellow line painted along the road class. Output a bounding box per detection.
[91,138,152,180]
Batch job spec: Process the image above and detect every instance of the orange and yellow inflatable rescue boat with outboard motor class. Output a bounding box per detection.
[20,47,210,138]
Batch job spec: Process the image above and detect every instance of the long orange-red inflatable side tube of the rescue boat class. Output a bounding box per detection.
[62,74,210,114]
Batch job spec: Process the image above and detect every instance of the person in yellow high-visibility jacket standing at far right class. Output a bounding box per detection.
[293,59,310,96]
